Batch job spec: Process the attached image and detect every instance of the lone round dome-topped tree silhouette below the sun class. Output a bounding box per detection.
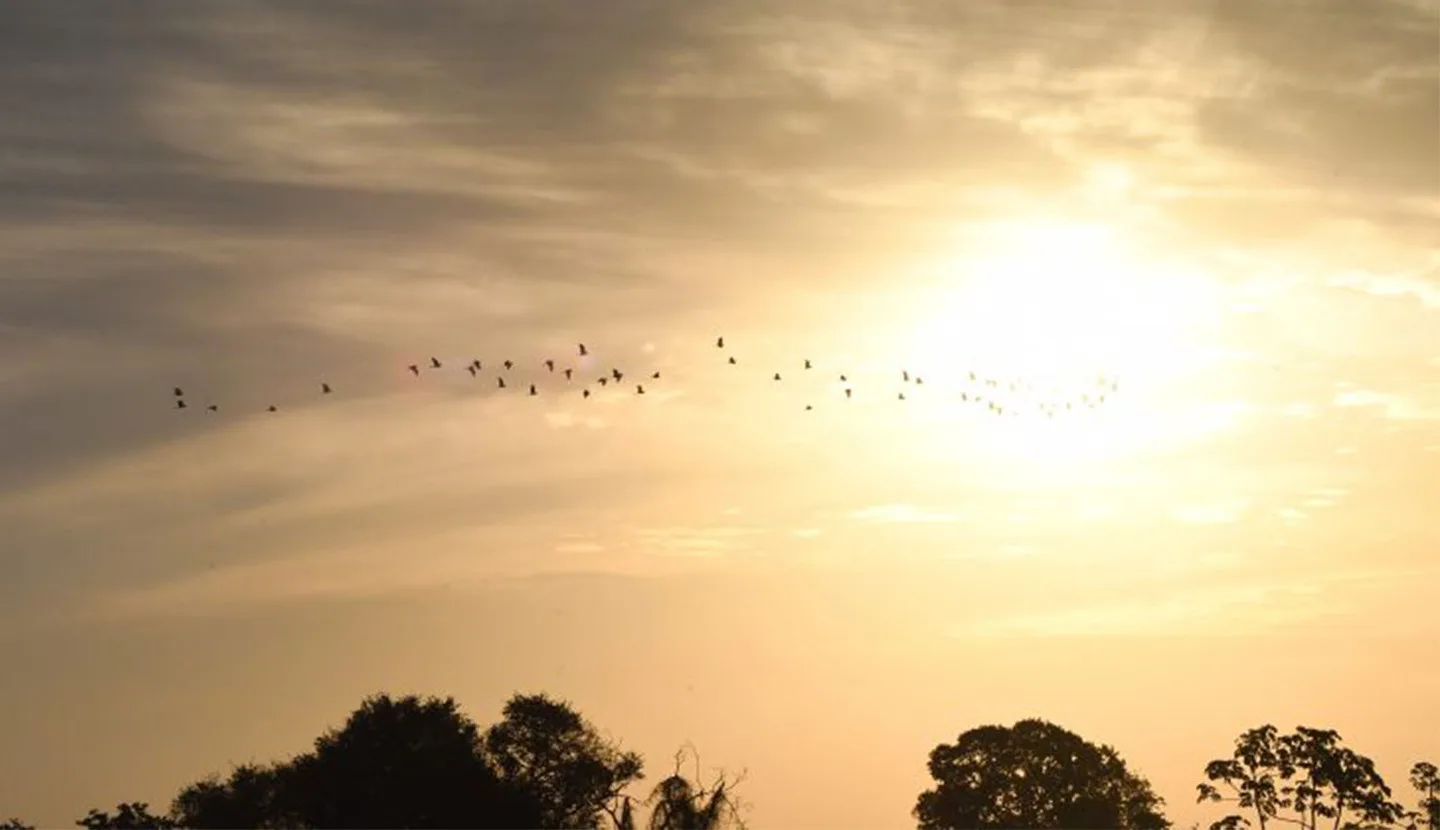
[914,719,1169,830]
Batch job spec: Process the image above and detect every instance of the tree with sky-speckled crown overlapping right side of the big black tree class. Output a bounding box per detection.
[484,695,644,830]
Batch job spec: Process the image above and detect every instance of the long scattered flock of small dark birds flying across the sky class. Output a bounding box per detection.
[174,336,1120,418]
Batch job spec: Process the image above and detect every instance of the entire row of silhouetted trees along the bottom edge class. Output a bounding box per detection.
[0,695,1440,830]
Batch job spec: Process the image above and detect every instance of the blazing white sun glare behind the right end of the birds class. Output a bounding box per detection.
[900,219,1207,464]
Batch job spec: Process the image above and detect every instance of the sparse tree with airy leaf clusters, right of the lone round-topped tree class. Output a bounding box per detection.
[1197,725,1404,830]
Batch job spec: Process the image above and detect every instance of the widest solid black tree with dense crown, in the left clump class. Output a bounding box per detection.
[275,695,540,829]
